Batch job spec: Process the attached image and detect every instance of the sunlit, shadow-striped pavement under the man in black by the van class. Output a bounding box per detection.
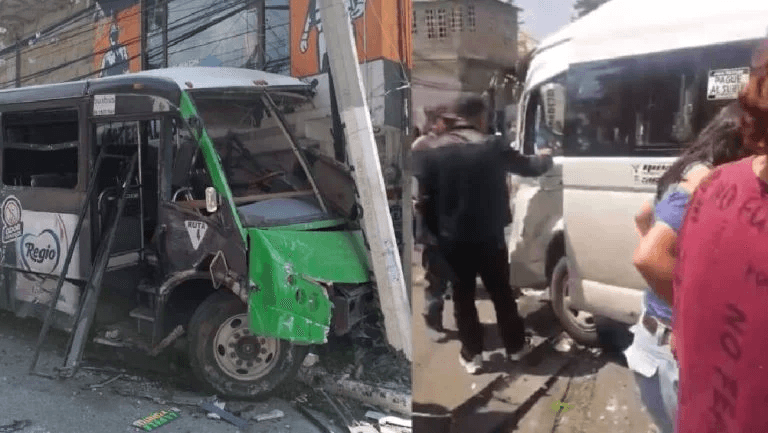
[413,255,656,433]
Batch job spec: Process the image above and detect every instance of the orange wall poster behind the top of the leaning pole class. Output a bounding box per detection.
[290,0,410,77]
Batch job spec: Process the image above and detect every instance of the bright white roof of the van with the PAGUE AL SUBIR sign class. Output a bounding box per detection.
[526,0,768,86]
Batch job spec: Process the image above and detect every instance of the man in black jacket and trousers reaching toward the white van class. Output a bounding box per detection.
[415,96,552,374]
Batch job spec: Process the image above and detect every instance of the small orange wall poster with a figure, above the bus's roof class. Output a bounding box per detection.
[93,3,141,77]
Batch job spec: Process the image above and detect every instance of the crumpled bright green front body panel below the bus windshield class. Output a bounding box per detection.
[248,229,371,344]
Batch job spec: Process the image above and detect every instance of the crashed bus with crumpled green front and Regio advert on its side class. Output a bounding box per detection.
[0,68,374,398]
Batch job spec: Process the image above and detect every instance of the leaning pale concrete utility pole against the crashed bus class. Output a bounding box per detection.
[318,0,413,360]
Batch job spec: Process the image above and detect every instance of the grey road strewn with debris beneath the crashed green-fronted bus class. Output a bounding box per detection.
[0,312,336,433]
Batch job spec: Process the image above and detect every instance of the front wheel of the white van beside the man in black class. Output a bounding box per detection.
[552,257,599,346]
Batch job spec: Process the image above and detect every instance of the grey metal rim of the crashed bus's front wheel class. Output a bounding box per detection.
[213,314,280,381]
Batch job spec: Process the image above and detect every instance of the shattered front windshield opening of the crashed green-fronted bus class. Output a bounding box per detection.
[192,92,329,227]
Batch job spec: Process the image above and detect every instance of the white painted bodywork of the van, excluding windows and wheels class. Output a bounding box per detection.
[509,0,768,324]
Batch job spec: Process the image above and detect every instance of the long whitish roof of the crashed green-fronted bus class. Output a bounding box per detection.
[0,66,311,105]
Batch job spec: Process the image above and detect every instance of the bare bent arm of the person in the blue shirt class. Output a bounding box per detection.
[632,222,677,305]
